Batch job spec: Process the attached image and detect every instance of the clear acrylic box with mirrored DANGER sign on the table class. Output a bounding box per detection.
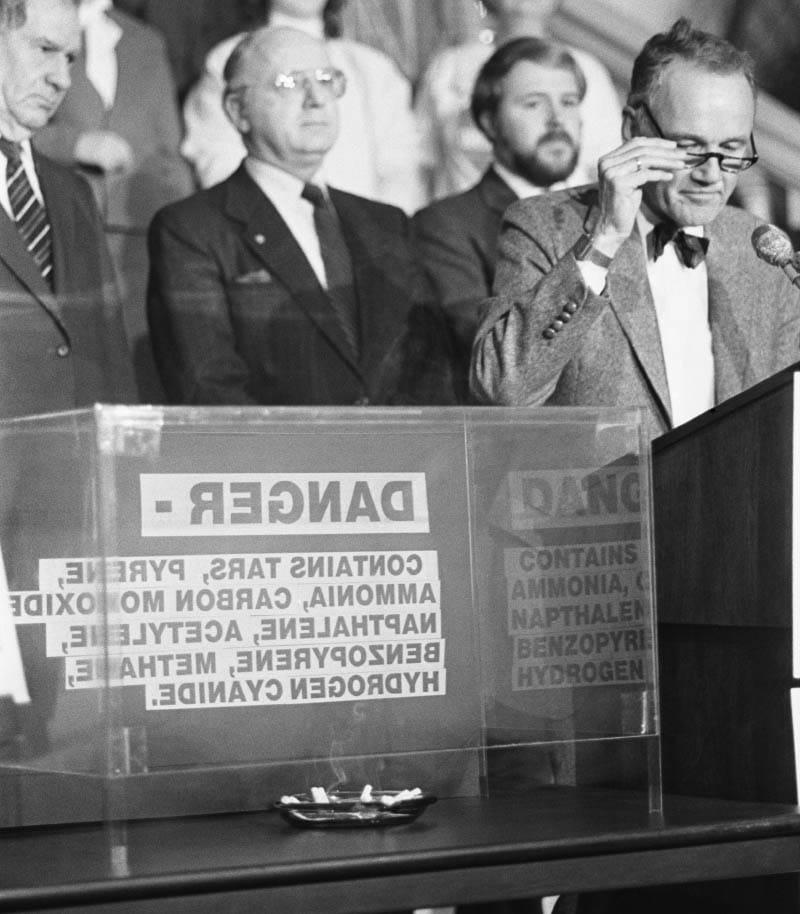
[0,407,657,825]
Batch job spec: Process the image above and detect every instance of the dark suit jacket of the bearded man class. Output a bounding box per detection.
[414,168,518,347]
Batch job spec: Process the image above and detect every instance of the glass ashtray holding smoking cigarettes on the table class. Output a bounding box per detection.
[275,788,436,828]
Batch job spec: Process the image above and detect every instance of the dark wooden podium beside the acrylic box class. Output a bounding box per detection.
[653,366,800,803]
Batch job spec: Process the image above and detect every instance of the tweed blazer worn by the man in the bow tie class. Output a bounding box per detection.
[471,185,800,437]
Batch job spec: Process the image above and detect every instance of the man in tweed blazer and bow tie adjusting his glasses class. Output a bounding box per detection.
[471,19,800,437]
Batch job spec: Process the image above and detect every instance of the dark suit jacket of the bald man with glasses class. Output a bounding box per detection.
[148,166,428,405]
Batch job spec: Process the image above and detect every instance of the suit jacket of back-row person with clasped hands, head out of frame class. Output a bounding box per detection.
[34,10,194,234]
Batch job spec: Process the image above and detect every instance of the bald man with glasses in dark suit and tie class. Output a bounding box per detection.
[148,28,422,405]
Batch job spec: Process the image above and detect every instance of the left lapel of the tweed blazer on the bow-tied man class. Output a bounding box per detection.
[587,211,672,425]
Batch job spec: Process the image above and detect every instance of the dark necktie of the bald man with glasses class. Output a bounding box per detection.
[301,184,360,359]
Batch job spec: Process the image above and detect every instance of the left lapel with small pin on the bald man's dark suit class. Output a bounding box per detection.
[225,166,358,373]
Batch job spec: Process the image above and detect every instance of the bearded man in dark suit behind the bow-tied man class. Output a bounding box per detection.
[414,37,586,349]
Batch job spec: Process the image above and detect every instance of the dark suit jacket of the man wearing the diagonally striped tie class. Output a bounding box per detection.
[0,156,133,417]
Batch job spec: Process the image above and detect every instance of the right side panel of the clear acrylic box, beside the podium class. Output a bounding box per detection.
[470,409,658,802]
